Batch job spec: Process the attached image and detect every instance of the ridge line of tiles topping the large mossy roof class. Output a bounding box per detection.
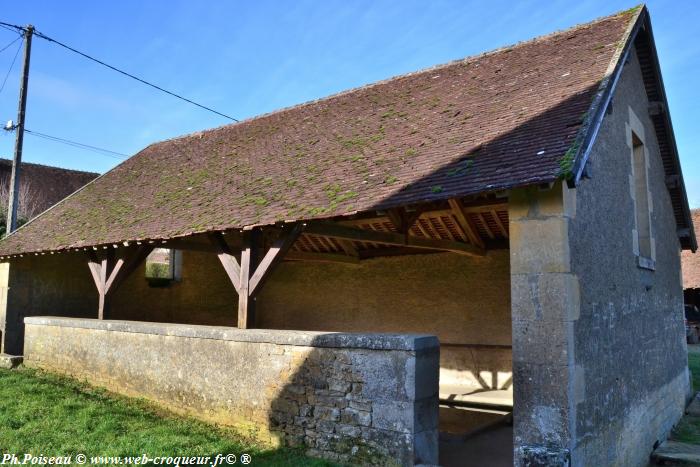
[159,3,645,147]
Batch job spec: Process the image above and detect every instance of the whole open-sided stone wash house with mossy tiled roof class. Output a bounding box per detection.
[0,7,696,466]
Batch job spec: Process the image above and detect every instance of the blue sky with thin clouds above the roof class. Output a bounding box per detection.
[0,0,700,207]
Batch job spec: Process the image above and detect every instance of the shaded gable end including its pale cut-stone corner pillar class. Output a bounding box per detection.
[509,44,690,466]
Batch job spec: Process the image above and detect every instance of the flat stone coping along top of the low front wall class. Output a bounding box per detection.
[24,316,440,351]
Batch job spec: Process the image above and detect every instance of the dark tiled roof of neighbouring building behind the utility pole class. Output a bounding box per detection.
[0,158,100,215]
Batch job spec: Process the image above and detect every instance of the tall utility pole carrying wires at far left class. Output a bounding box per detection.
[6,24,34,235]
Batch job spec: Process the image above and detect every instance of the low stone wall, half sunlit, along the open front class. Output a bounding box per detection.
[24,317,439,465]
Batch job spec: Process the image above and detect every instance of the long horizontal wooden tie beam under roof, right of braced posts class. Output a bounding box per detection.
[306,222,485,256]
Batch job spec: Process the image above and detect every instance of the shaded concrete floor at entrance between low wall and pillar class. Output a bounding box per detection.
[440,425,513,467]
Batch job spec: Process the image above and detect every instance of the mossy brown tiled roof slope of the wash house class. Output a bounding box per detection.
[0,9,641,255]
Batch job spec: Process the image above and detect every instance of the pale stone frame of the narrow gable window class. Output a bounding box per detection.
[625,107,656,271]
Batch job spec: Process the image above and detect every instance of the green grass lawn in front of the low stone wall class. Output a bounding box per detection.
[0,368,334,466]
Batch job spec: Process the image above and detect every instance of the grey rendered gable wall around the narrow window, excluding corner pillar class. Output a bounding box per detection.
[569,46,690,466]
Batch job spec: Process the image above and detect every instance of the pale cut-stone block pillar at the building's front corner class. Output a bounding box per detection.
[509,182,584,466]
